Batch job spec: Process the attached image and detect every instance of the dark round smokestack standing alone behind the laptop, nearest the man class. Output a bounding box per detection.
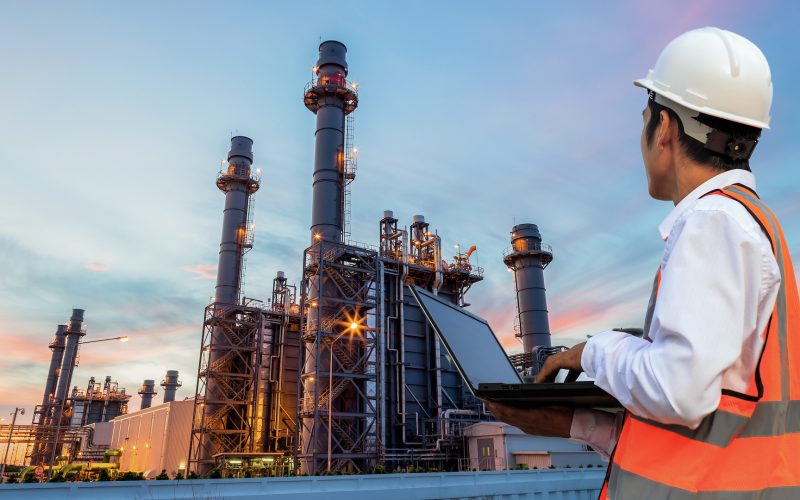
[503,224,553,353]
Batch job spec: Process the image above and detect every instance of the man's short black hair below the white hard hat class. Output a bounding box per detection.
[645,92,761,172]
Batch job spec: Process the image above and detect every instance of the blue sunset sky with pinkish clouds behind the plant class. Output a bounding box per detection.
[0,0,800,413]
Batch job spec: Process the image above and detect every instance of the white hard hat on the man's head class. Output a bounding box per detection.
[633,28,772,129]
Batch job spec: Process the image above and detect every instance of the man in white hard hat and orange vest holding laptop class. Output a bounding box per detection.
[488,28,800,499]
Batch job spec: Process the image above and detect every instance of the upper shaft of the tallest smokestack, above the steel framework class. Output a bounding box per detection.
[303,40,358,244]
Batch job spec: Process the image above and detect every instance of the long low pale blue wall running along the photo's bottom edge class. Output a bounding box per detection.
[0,469,605,500]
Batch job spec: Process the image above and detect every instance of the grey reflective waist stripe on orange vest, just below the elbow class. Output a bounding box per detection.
[631,401,800,448]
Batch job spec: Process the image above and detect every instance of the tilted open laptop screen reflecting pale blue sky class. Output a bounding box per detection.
[411,286,522,389]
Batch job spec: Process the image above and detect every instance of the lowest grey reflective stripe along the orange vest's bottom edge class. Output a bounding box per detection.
[608,464,800,500]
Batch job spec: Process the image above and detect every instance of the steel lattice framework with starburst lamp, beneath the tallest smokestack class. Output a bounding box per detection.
[298,241,383,474]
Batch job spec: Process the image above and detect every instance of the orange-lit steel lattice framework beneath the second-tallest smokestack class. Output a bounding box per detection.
[188,303,263,470]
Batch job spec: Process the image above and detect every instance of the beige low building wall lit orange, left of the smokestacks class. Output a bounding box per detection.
[111,400,194,478]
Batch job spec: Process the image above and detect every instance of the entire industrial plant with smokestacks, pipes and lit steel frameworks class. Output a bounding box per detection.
[3,41,597,477]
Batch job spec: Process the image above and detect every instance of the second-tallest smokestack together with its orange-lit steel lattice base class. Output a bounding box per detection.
[188,136,262,474]
